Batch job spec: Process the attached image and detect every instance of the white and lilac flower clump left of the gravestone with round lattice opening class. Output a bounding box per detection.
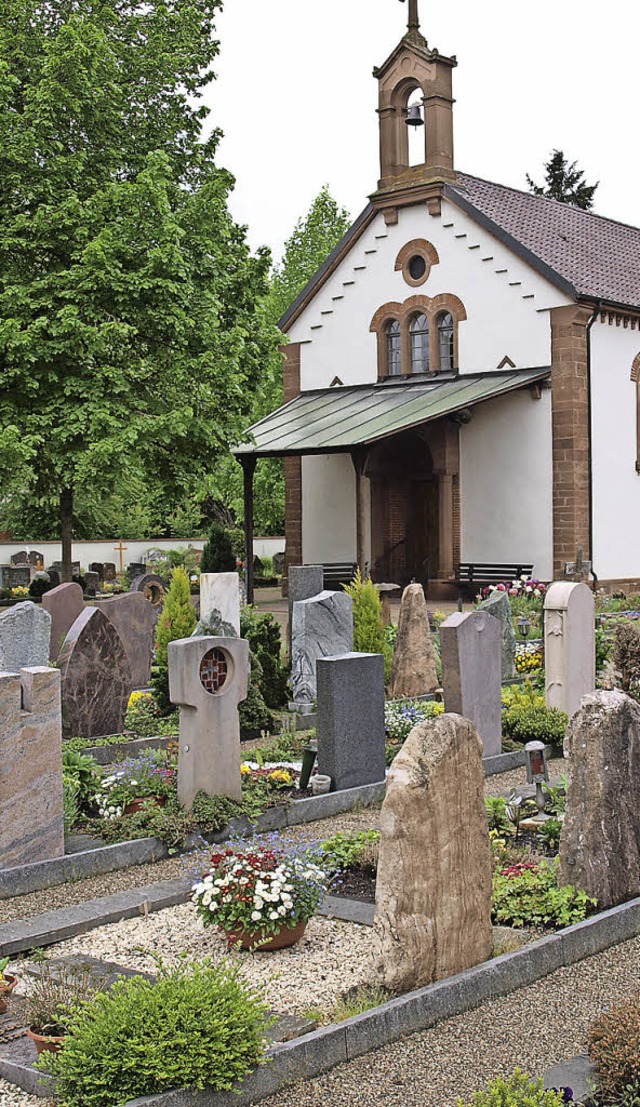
[95,753,176,819]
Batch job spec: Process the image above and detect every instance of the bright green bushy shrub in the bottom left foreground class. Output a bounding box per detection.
[47,962,267,1107]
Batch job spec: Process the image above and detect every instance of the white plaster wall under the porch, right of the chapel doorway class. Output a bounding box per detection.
[461,390,553,580]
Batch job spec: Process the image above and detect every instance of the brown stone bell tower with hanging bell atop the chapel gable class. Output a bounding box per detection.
[371,0,457,223]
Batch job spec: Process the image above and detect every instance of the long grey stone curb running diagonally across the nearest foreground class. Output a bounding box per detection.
[0,898,640,1107]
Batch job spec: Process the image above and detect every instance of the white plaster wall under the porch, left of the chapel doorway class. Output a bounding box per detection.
[302,454,357,565]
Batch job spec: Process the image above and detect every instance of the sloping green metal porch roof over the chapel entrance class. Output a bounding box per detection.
[234,366,550,457]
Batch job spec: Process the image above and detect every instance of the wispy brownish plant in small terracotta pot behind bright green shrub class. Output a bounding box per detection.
[25,961,104,1056]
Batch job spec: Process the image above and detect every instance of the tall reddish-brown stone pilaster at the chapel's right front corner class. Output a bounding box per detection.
[550,304,591,579]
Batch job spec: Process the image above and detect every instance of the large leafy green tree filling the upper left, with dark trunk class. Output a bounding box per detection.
[0,0,278,578]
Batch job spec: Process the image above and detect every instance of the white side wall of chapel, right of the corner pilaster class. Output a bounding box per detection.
[591,320,640,580]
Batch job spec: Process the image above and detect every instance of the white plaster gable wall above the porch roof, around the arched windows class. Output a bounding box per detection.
[289,201,569,390]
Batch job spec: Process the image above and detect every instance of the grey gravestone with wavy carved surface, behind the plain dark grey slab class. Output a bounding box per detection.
[291,592,353,714]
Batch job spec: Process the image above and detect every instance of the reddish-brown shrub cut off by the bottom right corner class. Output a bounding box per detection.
[588,1000,640,1104]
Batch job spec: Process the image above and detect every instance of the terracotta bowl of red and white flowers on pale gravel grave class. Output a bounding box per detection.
[192,838,329,950]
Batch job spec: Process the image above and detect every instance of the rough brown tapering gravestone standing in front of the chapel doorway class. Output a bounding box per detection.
[391,584,440,696]
